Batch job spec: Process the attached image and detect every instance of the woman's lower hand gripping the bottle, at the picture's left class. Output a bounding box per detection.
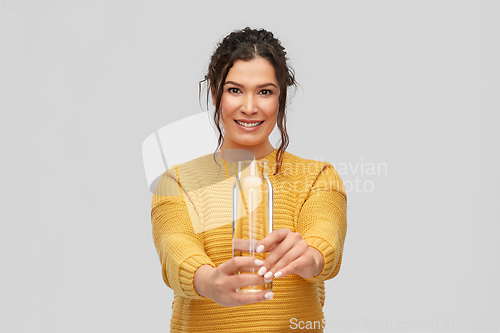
[193,257,273,306]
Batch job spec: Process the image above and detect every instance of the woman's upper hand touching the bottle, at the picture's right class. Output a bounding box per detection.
[257,228,324,282]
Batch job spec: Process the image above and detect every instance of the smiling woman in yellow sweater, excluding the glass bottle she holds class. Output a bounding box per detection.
[151,28,347,333]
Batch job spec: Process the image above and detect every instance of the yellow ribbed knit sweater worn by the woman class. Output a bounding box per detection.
[151,149,347,333]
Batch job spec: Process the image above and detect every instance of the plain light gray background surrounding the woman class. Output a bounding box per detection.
[0,0,500,333]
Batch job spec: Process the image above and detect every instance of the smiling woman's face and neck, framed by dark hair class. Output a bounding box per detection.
[221,57,280,158]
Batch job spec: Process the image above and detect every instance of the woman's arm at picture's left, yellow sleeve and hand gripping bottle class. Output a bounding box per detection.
[151,169,273,306]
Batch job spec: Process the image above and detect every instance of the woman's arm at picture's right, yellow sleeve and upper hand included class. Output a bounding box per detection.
[257,163,347,281]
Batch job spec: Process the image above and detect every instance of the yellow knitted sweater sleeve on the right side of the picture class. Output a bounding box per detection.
[297,163,347,282]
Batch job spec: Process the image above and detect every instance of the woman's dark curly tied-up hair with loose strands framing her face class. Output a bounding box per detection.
[200,27,297,174]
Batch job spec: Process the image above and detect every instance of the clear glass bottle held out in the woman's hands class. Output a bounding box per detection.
[233,160,273,293]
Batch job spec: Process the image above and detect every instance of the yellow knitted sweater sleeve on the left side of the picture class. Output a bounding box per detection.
[151,166,215,299]
